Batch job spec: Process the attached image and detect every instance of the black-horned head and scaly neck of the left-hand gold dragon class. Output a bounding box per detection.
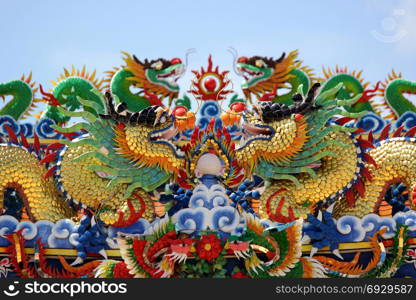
[102,93,184,173]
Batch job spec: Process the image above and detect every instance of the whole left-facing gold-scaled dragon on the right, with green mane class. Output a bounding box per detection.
[236,84,416,221]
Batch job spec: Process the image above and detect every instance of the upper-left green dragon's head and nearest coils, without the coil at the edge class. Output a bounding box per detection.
[42,52,185,124]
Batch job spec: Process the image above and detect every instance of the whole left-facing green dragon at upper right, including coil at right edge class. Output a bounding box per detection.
[236,51,416,118]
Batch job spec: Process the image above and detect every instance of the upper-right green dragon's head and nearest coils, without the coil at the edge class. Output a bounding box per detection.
[236,51,375,112]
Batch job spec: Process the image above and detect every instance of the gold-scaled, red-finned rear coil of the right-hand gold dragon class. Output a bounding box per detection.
[336,124,416,217]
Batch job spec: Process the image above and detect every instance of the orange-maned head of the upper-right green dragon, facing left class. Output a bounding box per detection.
[235,51,297,100]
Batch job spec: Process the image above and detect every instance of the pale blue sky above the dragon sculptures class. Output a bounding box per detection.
[0,0,416,115]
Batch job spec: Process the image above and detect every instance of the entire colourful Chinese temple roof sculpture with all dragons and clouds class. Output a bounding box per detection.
[0,51,416,278]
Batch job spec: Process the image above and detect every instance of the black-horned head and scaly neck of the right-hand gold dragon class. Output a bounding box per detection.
[236,84,319,173]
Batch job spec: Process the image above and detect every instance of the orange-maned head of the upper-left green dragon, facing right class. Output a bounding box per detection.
[124,53,185,100]
